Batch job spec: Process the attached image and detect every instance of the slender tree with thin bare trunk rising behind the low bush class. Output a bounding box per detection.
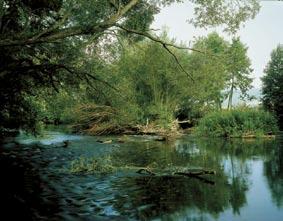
[226,38,252,109]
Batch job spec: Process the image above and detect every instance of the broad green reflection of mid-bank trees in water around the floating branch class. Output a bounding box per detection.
[109,140,263,220]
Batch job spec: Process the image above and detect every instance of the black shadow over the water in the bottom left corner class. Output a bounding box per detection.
[0,141,61,220]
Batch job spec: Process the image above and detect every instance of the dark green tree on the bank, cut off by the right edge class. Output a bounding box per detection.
[261,45,283,129]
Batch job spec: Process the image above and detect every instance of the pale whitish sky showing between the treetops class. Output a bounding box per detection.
[152,1,283,91]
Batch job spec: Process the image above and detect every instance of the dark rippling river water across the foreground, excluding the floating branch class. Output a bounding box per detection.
[0,132,283,221]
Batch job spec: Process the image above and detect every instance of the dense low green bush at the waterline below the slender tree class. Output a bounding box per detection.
[195,108,278,137]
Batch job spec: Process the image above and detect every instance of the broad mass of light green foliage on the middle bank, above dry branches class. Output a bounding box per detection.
[52,32,255,134]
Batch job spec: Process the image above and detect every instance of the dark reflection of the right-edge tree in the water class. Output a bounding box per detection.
[264,139,283,207]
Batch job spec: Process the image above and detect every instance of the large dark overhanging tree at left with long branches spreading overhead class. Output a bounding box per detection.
[0,0,259,129]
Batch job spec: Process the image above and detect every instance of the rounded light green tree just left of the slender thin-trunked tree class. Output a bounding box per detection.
[186,32,229,109]
